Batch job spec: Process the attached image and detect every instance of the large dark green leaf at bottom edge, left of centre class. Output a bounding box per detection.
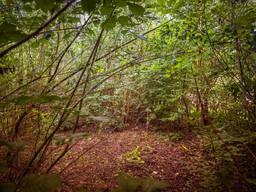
[23,174,61,192]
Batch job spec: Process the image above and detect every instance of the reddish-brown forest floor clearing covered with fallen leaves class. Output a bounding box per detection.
[47,129,207,192]
